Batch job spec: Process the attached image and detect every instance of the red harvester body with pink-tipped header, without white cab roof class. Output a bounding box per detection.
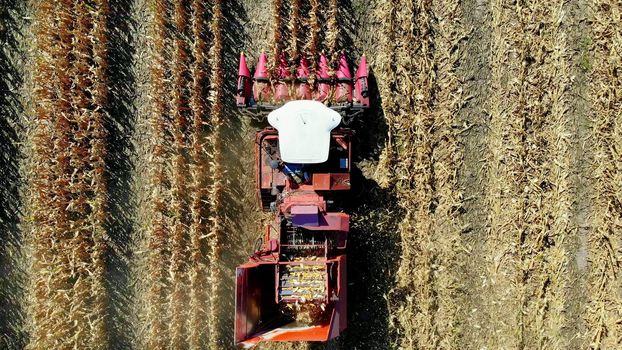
[234,49,369,347]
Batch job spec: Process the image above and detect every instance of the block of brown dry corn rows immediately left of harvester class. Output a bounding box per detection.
[143,0,223,349]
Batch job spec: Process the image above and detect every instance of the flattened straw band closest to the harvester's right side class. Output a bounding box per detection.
[377,2,462,349]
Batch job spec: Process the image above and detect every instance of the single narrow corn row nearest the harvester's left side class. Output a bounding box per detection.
[208,0,225,349]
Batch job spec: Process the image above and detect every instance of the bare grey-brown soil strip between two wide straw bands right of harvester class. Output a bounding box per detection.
[458,1,492,349]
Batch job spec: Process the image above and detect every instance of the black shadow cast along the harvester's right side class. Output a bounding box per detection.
[332,67,402,349]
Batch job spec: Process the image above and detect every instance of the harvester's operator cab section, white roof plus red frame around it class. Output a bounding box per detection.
[256,100,352,211]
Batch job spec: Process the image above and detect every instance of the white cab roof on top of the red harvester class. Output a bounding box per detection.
[268,100,341,164]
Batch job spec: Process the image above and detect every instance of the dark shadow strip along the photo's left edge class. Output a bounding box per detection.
[0,0,27,349]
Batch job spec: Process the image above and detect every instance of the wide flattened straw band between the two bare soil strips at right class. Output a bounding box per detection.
[486,2,588,348]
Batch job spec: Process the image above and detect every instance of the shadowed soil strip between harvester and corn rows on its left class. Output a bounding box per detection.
[212,1,249,349]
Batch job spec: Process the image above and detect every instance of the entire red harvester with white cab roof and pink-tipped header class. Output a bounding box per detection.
[234,53,369,347]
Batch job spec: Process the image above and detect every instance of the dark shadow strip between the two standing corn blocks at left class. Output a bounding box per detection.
[105,0,136,349]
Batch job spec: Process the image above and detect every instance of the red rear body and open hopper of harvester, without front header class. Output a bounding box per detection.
[235,128,352,347]
